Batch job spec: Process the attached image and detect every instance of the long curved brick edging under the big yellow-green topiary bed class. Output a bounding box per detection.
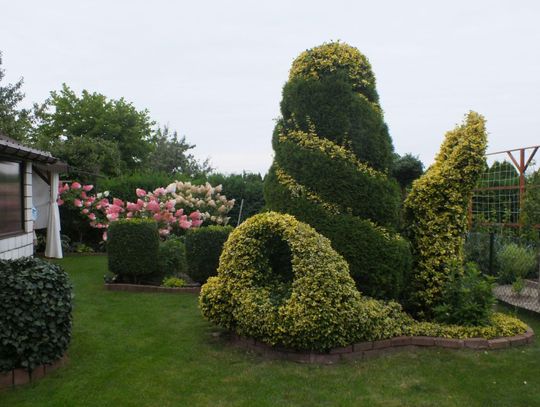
[231,328,534,364]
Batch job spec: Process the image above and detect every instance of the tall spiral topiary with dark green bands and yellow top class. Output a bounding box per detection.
[264,43,411,298]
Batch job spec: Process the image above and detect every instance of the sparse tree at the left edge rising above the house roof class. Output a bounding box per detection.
[0,51,32,141]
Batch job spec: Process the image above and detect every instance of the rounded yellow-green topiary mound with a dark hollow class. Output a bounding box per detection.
[199,212,411,350]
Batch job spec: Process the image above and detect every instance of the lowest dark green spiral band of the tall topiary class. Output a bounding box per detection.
[265,167,412,300]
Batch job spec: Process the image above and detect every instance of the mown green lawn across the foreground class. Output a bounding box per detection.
[0,257,540,407]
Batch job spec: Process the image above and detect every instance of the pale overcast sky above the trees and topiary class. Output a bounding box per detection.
[0,0,540,173]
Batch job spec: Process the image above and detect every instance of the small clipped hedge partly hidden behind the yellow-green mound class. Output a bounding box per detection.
[186,225,233,284]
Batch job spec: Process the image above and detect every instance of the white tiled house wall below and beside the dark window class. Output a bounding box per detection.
[0,162,34,260]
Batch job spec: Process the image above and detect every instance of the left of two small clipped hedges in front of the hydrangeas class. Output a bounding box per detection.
[107,219,159,283]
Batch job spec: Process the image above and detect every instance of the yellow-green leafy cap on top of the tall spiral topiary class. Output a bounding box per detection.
[289,42,379,103]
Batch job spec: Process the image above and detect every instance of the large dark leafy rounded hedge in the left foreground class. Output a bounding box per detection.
[0,257,72,372]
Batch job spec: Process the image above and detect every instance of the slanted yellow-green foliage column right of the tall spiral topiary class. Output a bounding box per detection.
[405,112,487,318]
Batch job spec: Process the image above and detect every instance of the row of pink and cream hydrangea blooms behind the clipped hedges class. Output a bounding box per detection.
[58,181,234,240]
